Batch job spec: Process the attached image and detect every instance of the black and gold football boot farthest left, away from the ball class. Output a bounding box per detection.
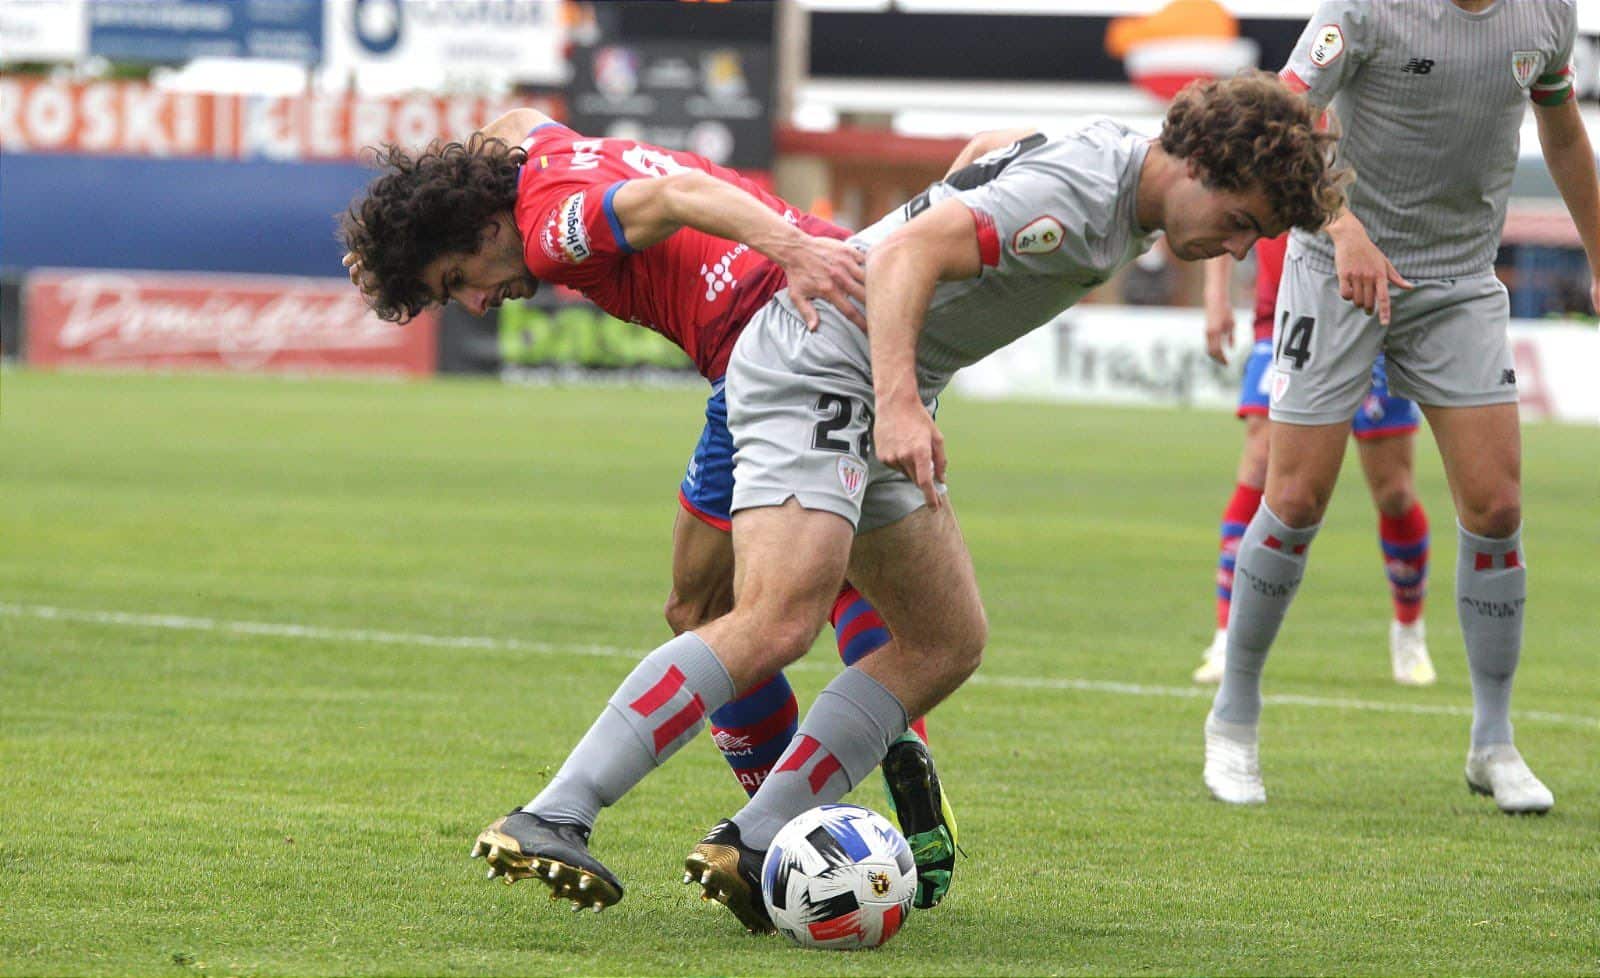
[472,808,622,914]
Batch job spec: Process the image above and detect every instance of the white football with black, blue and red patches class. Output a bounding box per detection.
[762,805,917,951]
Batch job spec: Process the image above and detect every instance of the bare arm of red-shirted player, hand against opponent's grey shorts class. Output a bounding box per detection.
[611,170,867,330]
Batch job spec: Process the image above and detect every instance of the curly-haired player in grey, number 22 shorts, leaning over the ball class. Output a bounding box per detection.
[505,75,1342,930]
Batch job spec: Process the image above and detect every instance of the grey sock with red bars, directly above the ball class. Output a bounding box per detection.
[733,667,907,848]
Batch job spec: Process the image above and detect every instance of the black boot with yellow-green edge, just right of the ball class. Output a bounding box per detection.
[882,730,957,911]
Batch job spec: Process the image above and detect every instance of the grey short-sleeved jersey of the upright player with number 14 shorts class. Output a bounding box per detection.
[1283,0,1578,279]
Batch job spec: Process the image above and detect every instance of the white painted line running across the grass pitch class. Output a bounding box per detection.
[0,603,1600,730]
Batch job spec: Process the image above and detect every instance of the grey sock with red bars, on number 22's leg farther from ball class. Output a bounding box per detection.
[525,632,733,828]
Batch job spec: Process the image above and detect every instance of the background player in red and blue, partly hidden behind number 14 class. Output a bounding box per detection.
[1194,237,1437,687]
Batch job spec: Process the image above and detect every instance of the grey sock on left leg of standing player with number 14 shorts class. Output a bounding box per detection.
[1211,503,1322,727]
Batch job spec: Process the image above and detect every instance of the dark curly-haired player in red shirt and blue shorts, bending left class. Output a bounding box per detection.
[342,109,995,908]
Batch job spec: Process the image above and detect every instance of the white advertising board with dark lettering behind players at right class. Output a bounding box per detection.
[952,306,1600,424]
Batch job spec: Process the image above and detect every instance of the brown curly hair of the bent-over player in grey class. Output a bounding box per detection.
[1162,72,1350,230]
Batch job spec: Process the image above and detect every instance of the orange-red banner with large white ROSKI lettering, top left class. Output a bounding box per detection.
[0,78,560,162]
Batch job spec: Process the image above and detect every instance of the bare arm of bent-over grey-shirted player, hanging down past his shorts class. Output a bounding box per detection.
[867,200,982,509]
